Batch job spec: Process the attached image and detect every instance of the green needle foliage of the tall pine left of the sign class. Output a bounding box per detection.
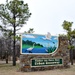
[0,0,31,30]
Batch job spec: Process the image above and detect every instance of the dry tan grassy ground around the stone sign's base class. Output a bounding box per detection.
[0,63,75,75]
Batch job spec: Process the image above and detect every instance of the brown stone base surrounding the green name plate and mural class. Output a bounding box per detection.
[20,37,70,72]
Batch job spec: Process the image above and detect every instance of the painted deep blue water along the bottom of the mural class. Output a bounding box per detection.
[22,47,47,53]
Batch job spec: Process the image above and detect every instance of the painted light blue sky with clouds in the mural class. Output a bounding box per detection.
[22,34,58,47]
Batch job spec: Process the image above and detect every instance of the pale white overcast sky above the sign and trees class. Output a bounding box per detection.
[0,0,75,35]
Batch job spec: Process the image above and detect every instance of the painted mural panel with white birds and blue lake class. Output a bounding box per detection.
[21,33,58,54]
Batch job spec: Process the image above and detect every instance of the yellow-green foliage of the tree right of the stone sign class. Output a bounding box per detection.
[62,21,75,49]
